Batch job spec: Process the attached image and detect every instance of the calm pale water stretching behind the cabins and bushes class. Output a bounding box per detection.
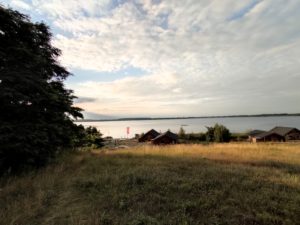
[78,116,300,138]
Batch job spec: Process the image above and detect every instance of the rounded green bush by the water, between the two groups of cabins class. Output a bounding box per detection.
[206,124,231,142]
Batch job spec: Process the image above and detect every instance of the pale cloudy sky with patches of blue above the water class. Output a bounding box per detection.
[1,0,300,117]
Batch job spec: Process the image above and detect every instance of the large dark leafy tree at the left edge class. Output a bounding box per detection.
[0,6,82,171]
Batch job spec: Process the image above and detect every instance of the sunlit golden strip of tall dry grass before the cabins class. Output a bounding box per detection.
[106,143,300,164]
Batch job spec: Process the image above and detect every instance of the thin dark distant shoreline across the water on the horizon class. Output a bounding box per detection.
[75,113,300,122]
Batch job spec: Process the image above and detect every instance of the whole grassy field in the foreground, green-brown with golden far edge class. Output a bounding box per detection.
[0,143,300,225]
